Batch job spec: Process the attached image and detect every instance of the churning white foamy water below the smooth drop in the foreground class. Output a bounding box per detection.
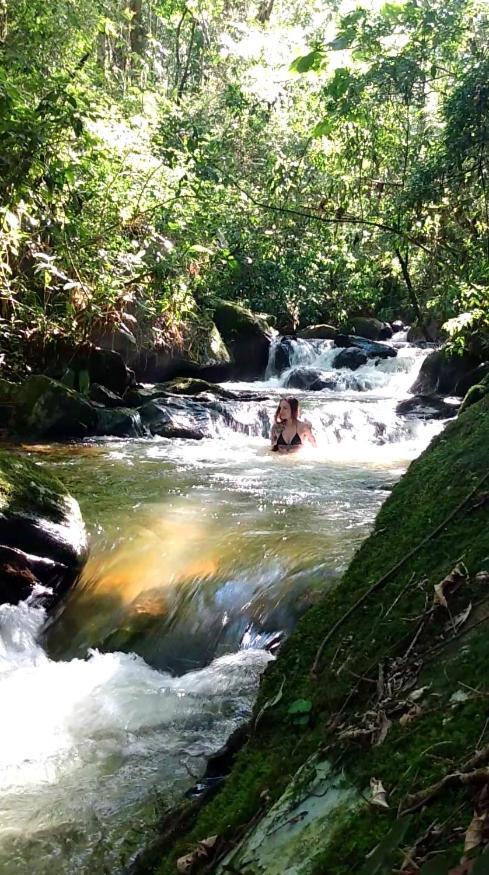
[0,603,271,875]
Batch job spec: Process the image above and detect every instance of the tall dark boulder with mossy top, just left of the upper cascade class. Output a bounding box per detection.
[214,301,271,380]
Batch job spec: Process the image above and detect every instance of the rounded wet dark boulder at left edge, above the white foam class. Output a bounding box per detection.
[0,450,87,604]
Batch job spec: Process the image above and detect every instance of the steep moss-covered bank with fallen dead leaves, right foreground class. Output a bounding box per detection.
[154,396,489,875]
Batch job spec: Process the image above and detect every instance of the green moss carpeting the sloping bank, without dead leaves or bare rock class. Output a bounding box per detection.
[154,396,489,875]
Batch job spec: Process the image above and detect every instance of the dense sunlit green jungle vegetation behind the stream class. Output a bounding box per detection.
[0,0,489,361]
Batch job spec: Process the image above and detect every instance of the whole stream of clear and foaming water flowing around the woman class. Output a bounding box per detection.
[0,337,443,875]
